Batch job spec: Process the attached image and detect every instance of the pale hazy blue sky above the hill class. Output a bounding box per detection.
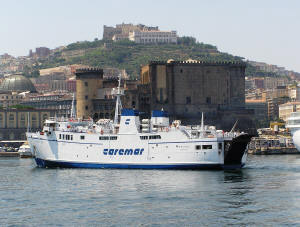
[0,0,300,72]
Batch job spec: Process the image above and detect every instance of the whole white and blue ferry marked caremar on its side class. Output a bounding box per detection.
[26,79,251,169]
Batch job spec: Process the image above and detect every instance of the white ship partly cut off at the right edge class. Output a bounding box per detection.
[285,112,300,151]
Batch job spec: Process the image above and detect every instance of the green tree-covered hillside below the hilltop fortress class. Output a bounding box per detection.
[35,37,288,78]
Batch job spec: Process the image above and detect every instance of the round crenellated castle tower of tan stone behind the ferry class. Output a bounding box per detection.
[75,68,103,118]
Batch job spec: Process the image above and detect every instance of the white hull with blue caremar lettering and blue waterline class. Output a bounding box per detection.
[27,131,247,169]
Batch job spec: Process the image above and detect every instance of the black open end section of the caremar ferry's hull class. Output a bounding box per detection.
[224,134,252,166]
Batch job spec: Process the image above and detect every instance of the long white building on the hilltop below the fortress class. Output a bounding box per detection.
[129,31,177,44]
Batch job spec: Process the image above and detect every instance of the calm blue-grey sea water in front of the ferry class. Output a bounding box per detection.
[0,155,300,226]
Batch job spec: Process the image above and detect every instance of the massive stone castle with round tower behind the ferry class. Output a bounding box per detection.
[76,60,254,133]
